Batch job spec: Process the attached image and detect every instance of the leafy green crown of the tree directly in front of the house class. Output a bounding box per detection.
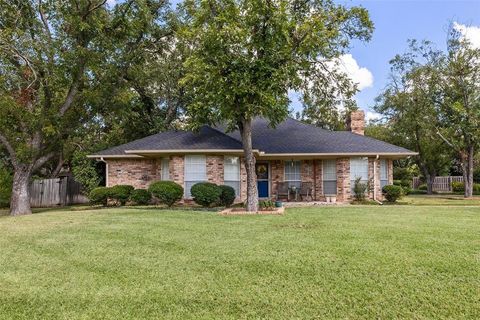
[180,0,373,129]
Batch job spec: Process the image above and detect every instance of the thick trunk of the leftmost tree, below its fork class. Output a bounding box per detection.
[10,165,32,216]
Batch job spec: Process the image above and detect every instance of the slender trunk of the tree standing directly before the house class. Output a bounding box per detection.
[239,119,258,212]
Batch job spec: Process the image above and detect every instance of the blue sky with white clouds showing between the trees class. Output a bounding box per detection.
[108,0,480,119]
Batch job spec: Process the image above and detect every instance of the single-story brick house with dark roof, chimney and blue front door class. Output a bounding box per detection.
[89,111,416,201]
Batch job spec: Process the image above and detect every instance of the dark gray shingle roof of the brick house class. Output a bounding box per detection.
[95,118,413,156]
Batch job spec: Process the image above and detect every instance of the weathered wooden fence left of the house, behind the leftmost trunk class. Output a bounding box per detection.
[30,177,88,207]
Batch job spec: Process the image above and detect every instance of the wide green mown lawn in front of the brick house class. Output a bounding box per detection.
[0,206,480,319]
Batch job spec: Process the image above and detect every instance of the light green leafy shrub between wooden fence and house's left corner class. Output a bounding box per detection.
[71,151,101,194]
